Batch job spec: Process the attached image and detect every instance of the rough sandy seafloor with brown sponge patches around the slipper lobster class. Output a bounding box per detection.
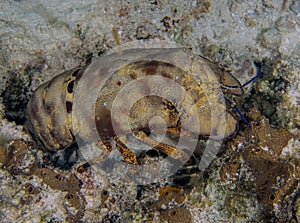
[0,0,300,223]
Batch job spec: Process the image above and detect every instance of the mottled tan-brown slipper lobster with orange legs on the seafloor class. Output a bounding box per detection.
[28,48,243,171]
